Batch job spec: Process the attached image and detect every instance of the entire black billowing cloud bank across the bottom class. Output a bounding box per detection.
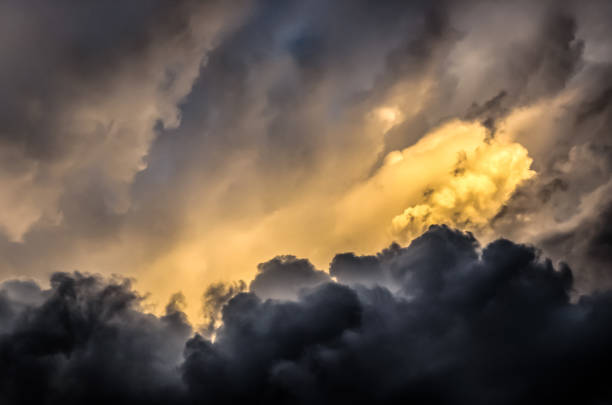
[0,226,612,404]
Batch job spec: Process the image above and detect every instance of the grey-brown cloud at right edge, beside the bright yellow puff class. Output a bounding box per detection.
[493,60,612,291]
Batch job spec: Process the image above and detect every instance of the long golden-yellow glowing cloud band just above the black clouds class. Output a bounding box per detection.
[139,117,535,319]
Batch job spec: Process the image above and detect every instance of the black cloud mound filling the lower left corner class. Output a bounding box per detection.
[0,273,191,404]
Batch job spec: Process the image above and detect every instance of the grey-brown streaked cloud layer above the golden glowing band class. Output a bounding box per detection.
[0,1,610,294]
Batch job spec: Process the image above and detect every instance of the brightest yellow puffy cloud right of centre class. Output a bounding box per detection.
[357,118,535,240]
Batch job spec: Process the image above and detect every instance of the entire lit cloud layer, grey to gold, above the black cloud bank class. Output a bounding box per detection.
[0,0,612,316]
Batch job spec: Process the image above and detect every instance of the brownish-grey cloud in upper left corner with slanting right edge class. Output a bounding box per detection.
[0,1,245,241]
